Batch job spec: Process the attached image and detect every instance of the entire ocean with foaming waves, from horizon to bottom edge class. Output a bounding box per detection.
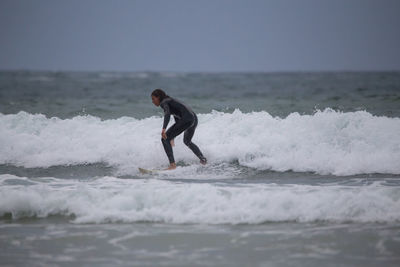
[0,71,400,266]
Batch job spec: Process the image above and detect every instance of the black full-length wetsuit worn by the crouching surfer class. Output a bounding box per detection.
[160,97,206,163]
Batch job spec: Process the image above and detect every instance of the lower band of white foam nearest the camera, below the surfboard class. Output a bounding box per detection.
[0,175,400,224]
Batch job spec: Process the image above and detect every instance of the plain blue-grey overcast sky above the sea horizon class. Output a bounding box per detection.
[0,0,400,72]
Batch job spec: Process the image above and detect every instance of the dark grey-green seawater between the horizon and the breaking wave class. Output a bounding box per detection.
[0,72,400,119]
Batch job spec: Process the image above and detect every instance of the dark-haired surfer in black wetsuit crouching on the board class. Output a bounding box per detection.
[151,89,207,170]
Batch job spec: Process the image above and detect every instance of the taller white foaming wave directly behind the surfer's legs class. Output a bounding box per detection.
[0,109,400,175]
